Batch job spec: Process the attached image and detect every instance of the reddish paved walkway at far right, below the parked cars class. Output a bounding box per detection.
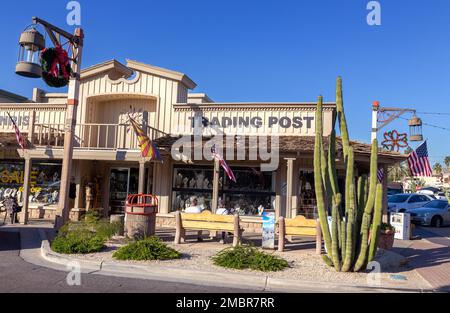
[394,228,450,292]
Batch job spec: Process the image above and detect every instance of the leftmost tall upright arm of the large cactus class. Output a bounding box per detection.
[314,96,332,256]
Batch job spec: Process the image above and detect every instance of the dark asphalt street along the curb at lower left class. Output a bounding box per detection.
[0,230,260,293]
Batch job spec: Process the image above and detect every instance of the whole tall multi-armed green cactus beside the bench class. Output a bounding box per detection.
[314,77,383,272]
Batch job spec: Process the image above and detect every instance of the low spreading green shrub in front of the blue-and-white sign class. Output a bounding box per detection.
[212,246,289,272]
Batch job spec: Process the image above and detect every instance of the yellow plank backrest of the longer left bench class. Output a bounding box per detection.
[181,211,234,231]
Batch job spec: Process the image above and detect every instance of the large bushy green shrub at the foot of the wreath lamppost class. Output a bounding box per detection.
[51,214,120,254]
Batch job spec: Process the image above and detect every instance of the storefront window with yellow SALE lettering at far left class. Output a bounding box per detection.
[0,161,62,205]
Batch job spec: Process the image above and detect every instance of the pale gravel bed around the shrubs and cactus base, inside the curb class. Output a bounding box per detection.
[65,230,429,289]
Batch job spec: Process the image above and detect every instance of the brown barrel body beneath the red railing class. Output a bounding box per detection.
[125,214,156,239]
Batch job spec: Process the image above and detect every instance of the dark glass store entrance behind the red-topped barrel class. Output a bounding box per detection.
[109,168,139,214]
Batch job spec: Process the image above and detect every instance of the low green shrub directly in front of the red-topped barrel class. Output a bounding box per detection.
[113,237,182,261]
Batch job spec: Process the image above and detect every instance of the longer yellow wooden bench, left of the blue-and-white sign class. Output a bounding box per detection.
[175,211,242,247]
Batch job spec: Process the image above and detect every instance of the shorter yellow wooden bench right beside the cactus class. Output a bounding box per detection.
[278,215,322,255]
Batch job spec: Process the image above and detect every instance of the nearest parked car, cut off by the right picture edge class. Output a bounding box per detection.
[408,200,450,227]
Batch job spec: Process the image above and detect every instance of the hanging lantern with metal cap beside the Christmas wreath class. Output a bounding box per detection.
[16,27,45,78]
